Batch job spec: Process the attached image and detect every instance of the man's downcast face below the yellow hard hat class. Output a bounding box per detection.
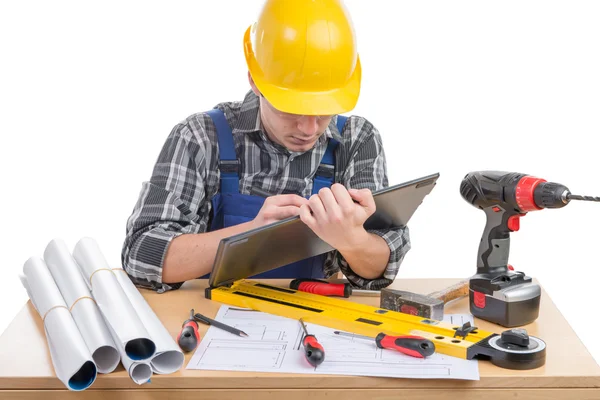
[260,96,332,152]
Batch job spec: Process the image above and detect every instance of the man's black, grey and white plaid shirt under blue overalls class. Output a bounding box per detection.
[121,91,410,292]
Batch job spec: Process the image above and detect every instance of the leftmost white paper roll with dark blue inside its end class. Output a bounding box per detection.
[19,257,97,391]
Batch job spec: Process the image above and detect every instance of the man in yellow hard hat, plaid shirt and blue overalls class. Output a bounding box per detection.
[122,0,410,292]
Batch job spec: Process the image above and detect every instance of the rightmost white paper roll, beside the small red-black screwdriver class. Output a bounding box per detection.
[113,267,185,374]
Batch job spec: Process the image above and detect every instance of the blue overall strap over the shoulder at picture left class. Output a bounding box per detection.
[206,108,240,193]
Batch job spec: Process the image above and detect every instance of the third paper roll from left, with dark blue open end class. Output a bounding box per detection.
[73,238,156,361]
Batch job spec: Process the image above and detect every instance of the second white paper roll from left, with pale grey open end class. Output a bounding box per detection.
[44,239,121,374]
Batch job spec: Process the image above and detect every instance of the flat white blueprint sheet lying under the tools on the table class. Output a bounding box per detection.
[186,306,479,380]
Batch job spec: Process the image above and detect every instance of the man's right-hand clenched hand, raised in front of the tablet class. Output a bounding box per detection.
[300,183,375,251]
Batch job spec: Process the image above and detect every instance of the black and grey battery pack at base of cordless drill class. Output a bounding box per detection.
[469,271,541,328]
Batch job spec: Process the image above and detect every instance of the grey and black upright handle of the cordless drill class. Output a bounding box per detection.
[477,205,519,275]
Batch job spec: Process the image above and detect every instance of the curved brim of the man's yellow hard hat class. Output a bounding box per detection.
[244,27,362,115]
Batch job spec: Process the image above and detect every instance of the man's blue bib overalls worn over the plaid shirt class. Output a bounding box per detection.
[208,109,347,279]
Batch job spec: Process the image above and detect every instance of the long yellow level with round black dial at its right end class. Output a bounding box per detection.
[205,279,546,369]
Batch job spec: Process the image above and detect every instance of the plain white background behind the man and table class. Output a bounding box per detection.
[0,0,600,368]
